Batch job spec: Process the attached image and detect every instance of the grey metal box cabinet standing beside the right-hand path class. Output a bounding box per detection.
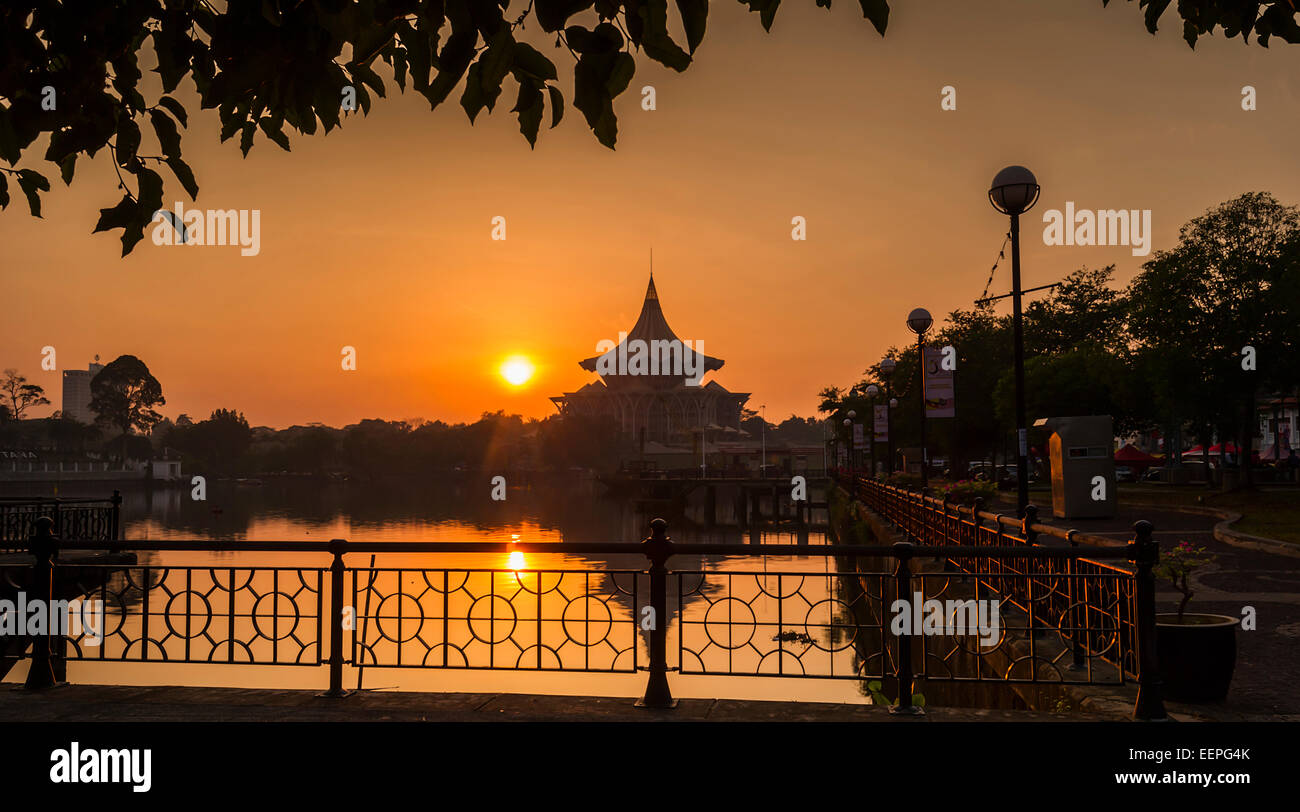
[1034,414,1117,518]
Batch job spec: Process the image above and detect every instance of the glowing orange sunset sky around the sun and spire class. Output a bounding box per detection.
[0,0,1300,426]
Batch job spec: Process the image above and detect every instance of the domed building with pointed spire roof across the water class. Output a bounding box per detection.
[551,275,749,446]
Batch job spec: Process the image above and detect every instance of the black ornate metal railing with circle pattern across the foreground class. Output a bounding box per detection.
[3,506,1164,718]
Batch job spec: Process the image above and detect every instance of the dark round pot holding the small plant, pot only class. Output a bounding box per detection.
[1156,612,1242,702]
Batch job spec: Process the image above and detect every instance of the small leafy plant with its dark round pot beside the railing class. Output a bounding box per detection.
[1156,542,1240,702]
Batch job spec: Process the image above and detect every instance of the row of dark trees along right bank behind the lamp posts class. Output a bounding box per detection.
[819,192,1300,483]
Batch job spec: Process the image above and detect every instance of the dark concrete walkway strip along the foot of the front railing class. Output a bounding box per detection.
[0,685,1122,724]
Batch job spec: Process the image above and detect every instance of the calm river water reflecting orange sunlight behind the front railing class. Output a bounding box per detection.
[8,477,868,703]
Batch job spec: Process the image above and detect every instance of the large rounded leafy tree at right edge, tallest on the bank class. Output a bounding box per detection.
[1127,192,1300,483]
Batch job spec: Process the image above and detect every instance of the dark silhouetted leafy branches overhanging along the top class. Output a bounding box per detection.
[0,0,1300,256]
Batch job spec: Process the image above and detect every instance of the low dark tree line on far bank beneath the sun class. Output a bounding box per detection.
[0,371,822,478]
